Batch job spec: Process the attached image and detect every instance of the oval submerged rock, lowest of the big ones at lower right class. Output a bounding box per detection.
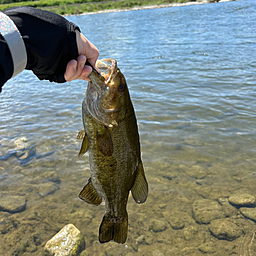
[209,219,243,241]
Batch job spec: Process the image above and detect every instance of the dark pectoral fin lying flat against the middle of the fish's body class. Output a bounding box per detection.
[96,128,113,156]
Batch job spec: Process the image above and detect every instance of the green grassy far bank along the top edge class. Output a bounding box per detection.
[0,0,218,15]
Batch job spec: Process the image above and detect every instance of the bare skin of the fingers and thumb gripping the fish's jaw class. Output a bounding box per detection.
[64,30,99,81]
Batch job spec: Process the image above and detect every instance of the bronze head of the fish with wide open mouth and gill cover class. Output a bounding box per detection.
[86,59,131,127]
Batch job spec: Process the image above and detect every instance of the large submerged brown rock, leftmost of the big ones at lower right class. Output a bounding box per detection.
[192,199,225,224]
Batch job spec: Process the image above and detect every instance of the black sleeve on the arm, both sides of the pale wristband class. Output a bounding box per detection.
[0,7,80,93]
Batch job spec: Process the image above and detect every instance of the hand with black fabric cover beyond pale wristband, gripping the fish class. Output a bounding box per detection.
[4,7,99,83]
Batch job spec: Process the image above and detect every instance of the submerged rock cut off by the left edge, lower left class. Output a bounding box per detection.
[0,194,27,213]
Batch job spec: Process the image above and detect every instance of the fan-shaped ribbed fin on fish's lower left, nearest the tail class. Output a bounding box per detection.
[79,178,102,205]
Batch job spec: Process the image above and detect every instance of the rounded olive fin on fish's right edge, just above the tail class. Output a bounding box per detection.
[131,162,148,204]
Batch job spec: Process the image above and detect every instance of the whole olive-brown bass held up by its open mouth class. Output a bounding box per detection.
[78,59,148,244]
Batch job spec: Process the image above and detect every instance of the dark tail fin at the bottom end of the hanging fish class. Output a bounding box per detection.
[99,212,128,244]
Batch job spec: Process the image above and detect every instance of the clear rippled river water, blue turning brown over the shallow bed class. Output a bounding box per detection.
[0,0,256,256]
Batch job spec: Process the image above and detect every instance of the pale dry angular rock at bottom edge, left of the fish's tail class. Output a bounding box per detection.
[44,224,85,256]
